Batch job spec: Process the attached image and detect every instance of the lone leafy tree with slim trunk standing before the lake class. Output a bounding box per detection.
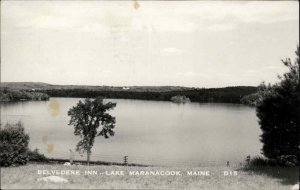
[68,97,116,165]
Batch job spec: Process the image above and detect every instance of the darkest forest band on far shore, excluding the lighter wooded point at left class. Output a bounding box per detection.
[41,86,257,103]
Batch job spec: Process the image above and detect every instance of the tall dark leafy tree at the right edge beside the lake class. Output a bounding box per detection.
[256,46,300,164]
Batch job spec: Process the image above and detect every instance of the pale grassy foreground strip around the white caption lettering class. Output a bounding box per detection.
[1,164,298,190]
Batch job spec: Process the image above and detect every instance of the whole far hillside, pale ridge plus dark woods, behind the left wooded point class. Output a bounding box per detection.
[1,82,257,104]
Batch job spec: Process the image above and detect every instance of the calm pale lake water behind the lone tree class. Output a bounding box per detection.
[1,98,262,165]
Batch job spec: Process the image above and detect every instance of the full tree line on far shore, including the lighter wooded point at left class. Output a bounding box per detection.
[0,86,257,104]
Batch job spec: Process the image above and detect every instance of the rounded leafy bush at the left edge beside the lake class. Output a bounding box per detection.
[0,122,29,167]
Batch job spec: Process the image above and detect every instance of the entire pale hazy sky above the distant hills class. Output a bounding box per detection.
[1,1,299,88]
